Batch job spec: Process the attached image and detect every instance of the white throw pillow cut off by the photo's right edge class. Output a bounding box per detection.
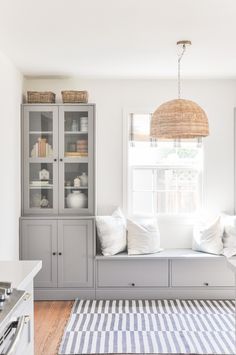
[222,214,236,258]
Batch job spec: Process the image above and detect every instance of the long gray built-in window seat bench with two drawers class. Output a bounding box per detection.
[95,249,234,299]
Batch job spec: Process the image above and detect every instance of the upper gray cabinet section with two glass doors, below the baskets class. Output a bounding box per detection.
[22,104,95,215]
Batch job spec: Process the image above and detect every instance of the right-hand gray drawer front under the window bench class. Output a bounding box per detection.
[172,258,234,287]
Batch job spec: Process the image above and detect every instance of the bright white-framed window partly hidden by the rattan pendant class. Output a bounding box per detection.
[126,114,203,216]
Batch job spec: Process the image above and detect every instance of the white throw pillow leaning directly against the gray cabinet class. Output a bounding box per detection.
[96,208,127,256]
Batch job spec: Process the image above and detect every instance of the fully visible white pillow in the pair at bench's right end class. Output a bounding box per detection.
[192,217,223,255]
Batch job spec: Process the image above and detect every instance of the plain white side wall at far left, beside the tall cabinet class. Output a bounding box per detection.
[0,53,23,259]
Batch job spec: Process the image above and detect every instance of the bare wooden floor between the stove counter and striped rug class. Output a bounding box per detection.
[34,301,73,355]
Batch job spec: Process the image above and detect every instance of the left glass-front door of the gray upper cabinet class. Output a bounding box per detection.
[23,105,58,214]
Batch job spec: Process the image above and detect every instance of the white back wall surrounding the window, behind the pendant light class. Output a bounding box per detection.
[24,78,236,247]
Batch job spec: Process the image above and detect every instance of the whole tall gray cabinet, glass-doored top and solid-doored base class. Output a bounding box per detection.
[20,104,95,299]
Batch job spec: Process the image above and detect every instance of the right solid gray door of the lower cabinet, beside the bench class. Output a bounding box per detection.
[58,220,93,287]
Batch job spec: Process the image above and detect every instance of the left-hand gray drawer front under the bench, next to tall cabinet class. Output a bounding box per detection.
[97,260,168,287]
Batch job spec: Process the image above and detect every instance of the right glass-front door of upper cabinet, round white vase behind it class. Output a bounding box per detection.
[59,105,94,215]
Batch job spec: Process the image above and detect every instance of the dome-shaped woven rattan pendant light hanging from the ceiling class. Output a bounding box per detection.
[151,41,209,139]
